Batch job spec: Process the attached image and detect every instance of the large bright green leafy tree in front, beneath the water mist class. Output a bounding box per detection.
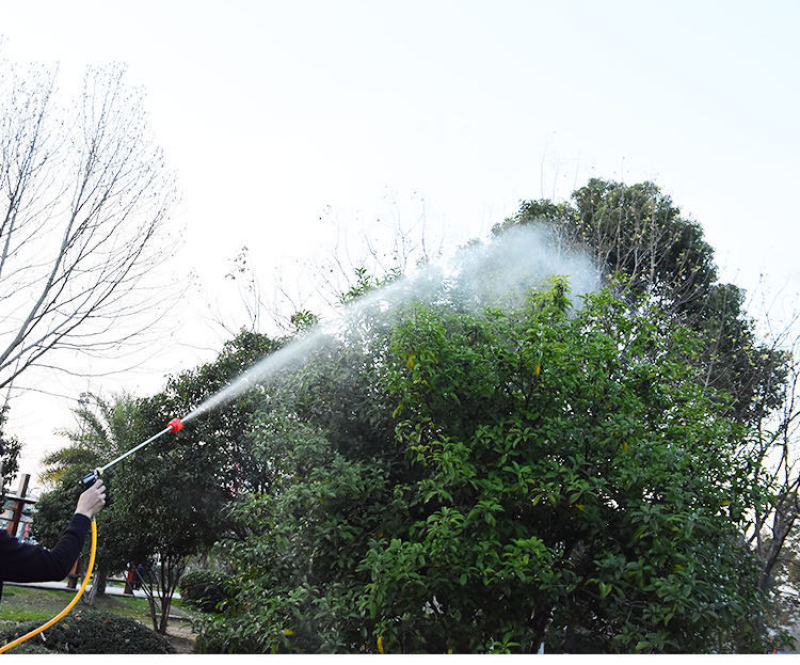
[364,282,765,652]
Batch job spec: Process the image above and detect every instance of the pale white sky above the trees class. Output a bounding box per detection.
[0,0,800,488]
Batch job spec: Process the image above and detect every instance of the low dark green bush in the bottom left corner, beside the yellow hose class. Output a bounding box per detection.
[0,610,175,654]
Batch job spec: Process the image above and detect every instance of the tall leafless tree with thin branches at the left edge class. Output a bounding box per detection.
[0,60,175,387]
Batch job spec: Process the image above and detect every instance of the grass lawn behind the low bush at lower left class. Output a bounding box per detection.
[0,584,194,653]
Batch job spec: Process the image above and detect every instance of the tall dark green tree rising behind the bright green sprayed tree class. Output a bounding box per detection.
[494,179,786,423]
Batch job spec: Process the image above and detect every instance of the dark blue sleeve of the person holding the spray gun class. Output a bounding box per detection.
[0,513,91,582]
